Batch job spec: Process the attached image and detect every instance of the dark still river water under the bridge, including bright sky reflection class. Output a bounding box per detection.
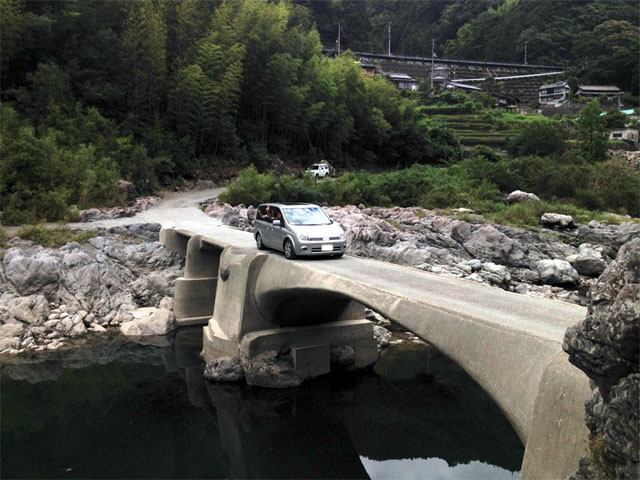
[1,328,523,478]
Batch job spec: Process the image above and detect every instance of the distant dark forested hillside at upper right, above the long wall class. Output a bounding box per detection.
[306,0,640,95]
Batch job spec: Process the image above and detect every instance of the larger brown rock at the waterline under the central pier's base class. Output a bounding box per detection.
[241,350,303,388]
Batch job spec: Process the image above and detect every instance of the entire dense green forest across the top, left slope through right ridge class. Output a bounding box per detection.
[0,0,638,224]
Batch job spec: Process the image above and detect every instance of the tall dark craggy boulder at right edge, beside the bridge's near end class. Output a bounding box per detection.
[562,238,640,479]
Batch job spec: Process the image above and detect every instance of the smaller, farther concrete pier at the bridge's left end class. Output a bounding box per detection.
[174,235,222,326]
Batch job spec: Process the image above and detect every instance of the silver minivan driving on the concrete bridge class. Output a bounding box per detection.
[253,203,347,260]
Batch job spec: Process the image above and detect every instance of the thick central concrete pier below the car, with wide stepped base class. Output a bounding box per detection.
[203,249,378,381]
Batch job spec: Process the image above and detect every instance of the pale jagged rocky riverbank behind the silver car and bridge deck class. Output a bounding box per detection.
[203,202,640,305]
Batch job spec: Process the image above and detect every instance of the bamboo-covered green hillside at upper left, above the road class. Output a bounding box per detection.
[0,0,460,223]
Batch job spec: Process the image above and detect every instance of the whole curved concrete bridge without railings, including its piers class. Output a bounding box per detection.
[161,226,590,478]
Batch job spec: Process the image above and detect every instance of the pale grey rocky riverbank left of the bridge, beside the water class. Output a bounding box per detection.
[0,224,184,355]
